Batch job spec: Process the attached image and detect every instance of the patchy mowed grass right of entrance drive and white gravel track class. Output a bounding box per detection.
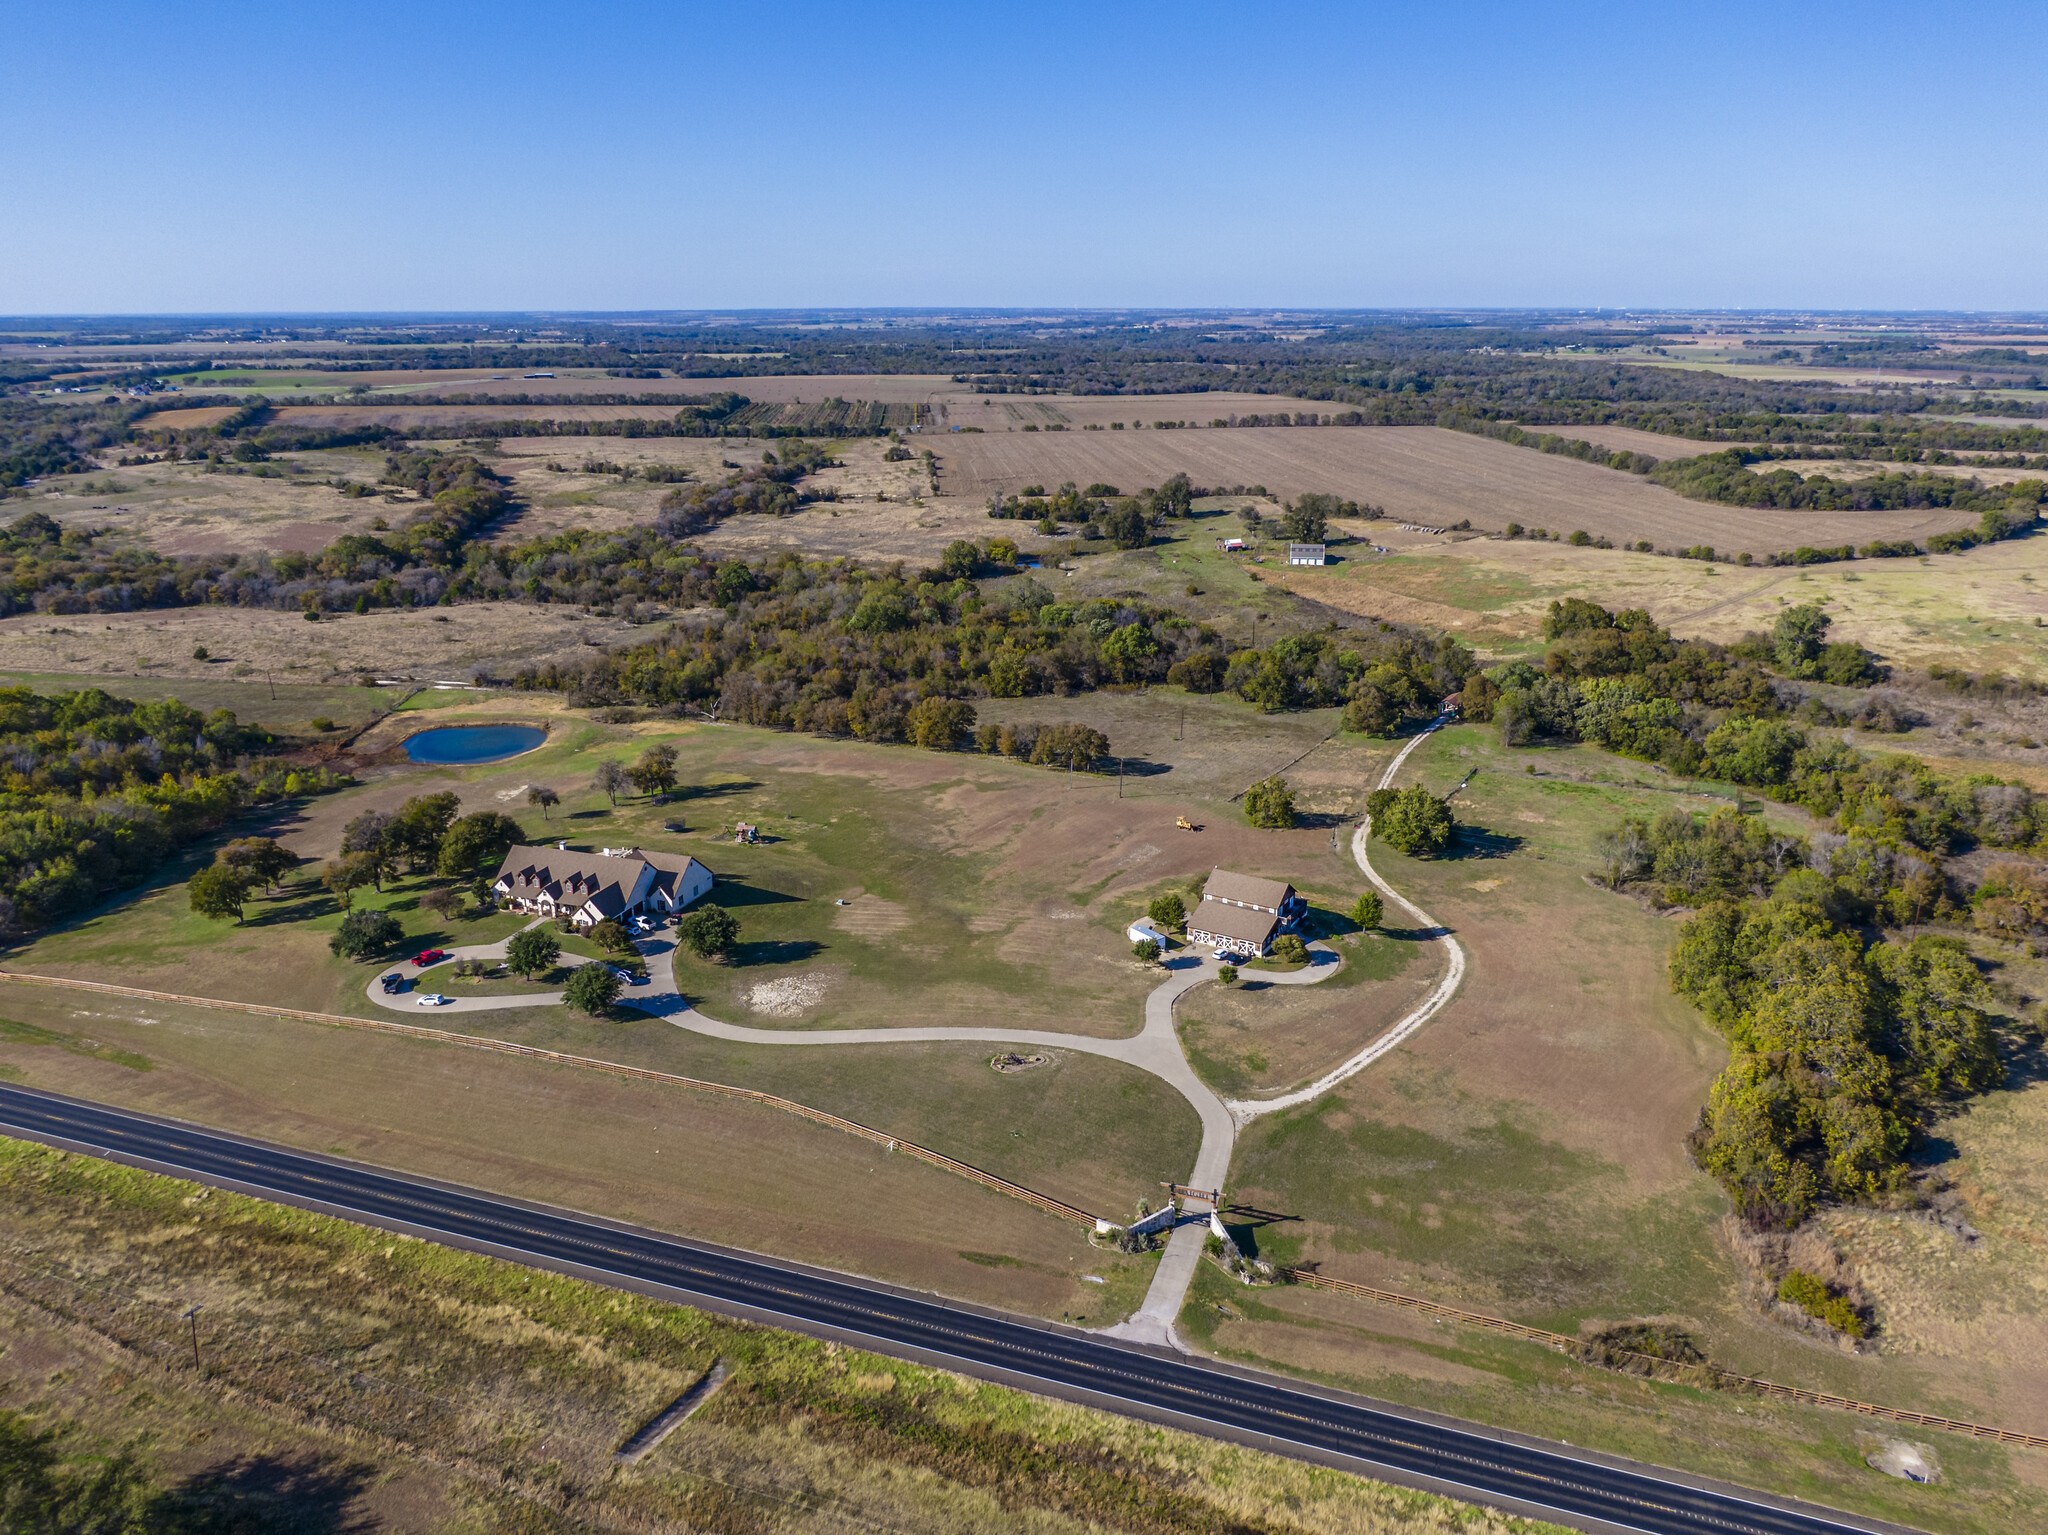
[1184,727,2048,1531]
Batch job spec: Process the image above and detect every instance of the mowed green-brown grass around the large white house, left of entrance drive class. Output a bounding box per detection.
[0,694,1370,1318]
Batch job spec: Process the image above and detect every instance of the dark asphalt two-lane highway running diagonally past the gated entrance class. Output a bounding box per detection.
[0,1083,1900,1535]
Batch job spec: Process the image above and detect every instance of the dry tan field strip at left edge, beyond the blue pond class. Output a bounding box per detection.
[0,602,645,686]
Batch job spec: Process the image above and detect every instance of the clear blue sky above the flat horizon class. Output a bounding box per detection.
[0,0,2048,313]
